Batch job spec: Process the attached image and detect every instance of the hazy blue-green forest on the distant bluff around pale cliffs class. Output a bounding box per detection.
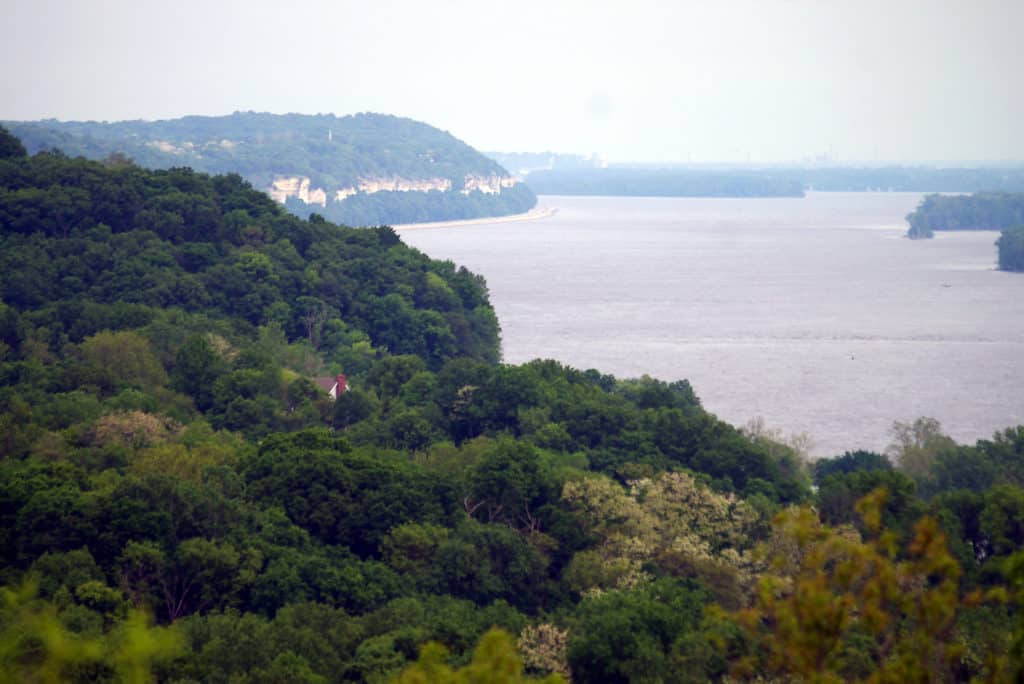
[5,112,537,225]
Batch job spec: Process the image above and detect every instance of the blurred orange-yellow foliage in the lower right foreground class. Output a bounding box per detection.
[733,489,999,683]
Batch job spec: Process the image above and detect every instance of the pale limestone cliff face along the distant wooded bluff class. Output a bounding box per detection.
[267,174,518,207]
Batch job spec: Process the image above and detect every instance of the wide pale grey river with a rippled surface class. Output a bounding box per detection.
[401,193,1024,456]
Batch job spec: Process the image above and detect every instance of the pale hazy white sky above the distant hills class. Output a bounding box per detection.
[0,0,1024,162]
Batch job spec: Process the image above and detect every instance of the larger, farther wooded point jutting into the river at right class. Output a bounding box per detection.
[906,193,1024,239]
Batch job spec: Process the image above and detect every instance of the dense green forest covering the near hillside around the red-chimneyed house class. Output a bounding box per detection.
[6,129,1024,684]
